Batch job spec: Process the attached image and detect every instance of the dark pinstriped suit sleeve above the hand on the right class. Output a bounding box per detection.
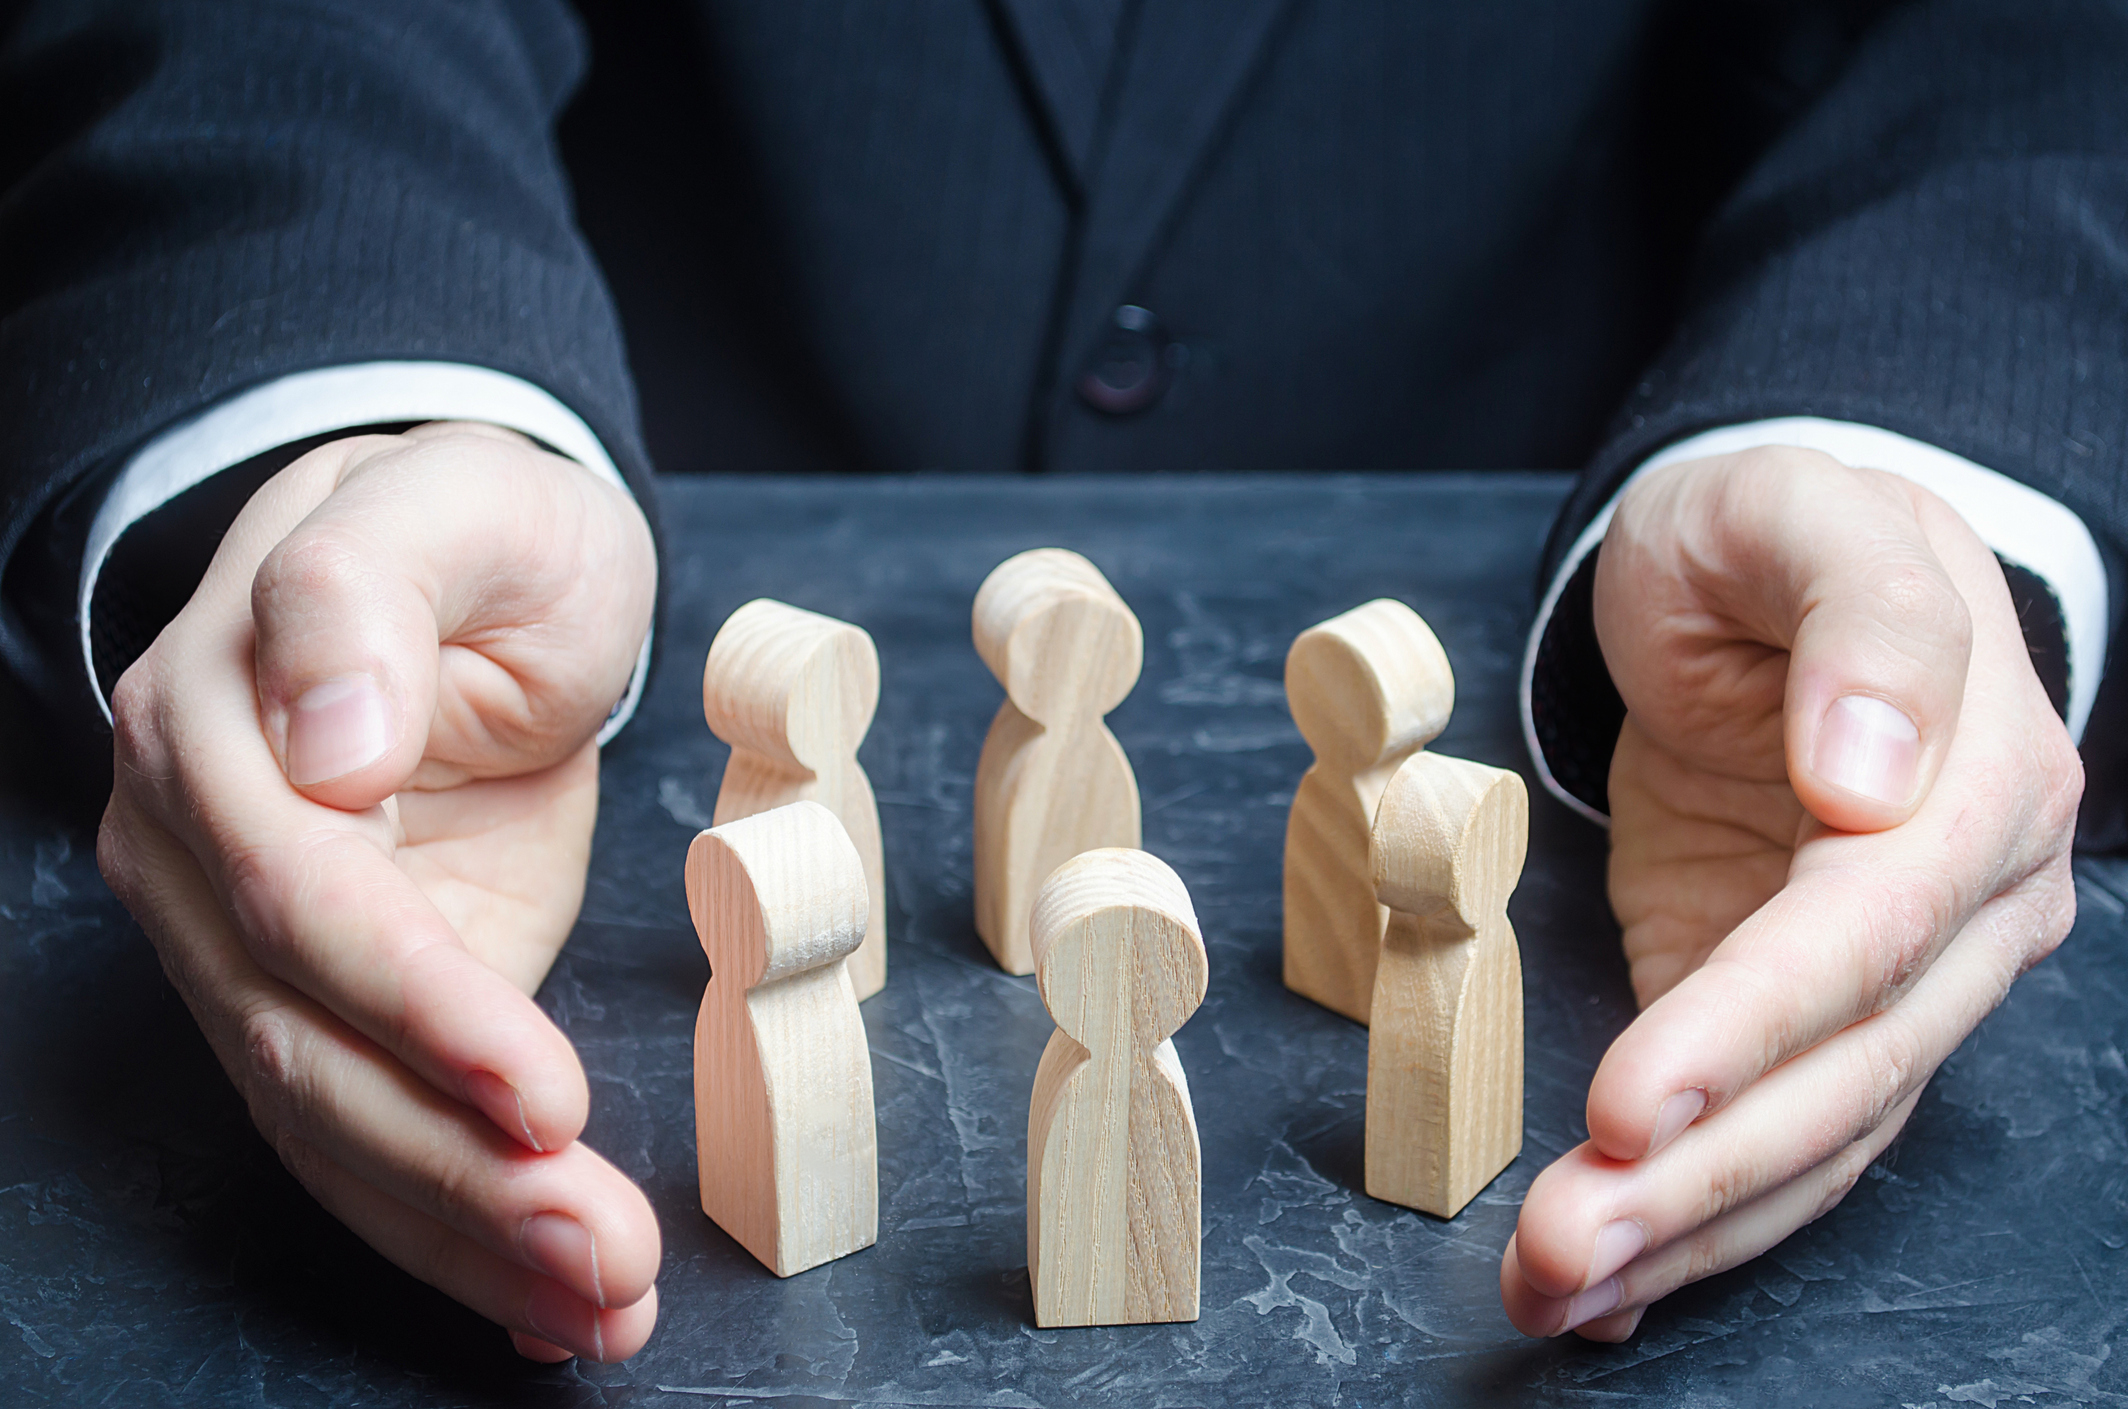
[1530,0,2128,849]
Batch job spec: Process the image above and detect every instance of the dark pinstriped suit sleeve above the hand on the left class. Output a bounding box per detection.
[0,0,655,719]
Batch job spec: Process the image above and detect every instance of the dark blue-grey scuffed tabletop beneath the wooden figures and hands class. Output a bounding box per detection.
[0,475,2128,1409]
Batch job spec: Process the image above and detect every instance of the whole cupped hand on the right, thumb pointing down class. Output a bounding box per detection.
[1500,449,2083,1341]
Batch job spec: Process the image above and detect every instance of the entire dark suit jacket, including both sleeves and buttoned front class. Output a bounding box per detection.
[0,0,2128,845]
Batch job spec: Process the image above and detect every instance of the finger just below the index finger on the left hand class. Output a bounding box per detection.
[104,817,660,1305]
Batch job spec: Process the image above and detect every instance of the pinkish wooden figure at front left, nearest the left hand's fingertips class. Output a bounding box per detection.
[687,802,879,1277]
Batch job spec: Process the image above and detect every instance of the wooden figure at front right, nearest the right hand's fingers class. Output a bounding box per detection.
[1366,753,1530,1217]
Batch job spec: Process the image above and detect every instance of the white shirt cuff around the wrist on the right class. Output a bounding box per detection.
[1522,415,2109,826]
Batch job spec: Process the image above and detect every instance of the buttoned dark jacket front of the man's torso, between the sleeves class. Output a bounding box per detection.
[562,0,1830,481]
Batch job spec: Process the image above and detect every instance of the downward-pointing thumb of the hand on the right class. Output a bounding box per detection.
[1760,455,1973,832]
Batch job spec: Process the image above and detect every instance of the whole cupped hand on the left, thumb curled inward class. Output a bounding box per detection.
[98,426,660,1360]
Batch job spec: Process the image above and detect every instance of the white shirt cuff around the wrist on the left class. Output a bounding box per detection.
[74,362,651,743]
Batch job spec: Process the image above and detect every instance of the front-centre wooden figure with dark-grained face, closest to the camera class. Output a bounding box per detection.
[1028,847,1207,1326]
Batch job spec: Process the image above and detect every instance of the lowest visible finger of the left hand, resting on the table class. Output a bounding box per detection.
[281,1139,658,1362]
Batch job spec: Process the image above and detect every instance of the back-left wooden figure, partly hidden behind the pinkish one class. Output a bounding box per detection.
[702,598,887,998]
